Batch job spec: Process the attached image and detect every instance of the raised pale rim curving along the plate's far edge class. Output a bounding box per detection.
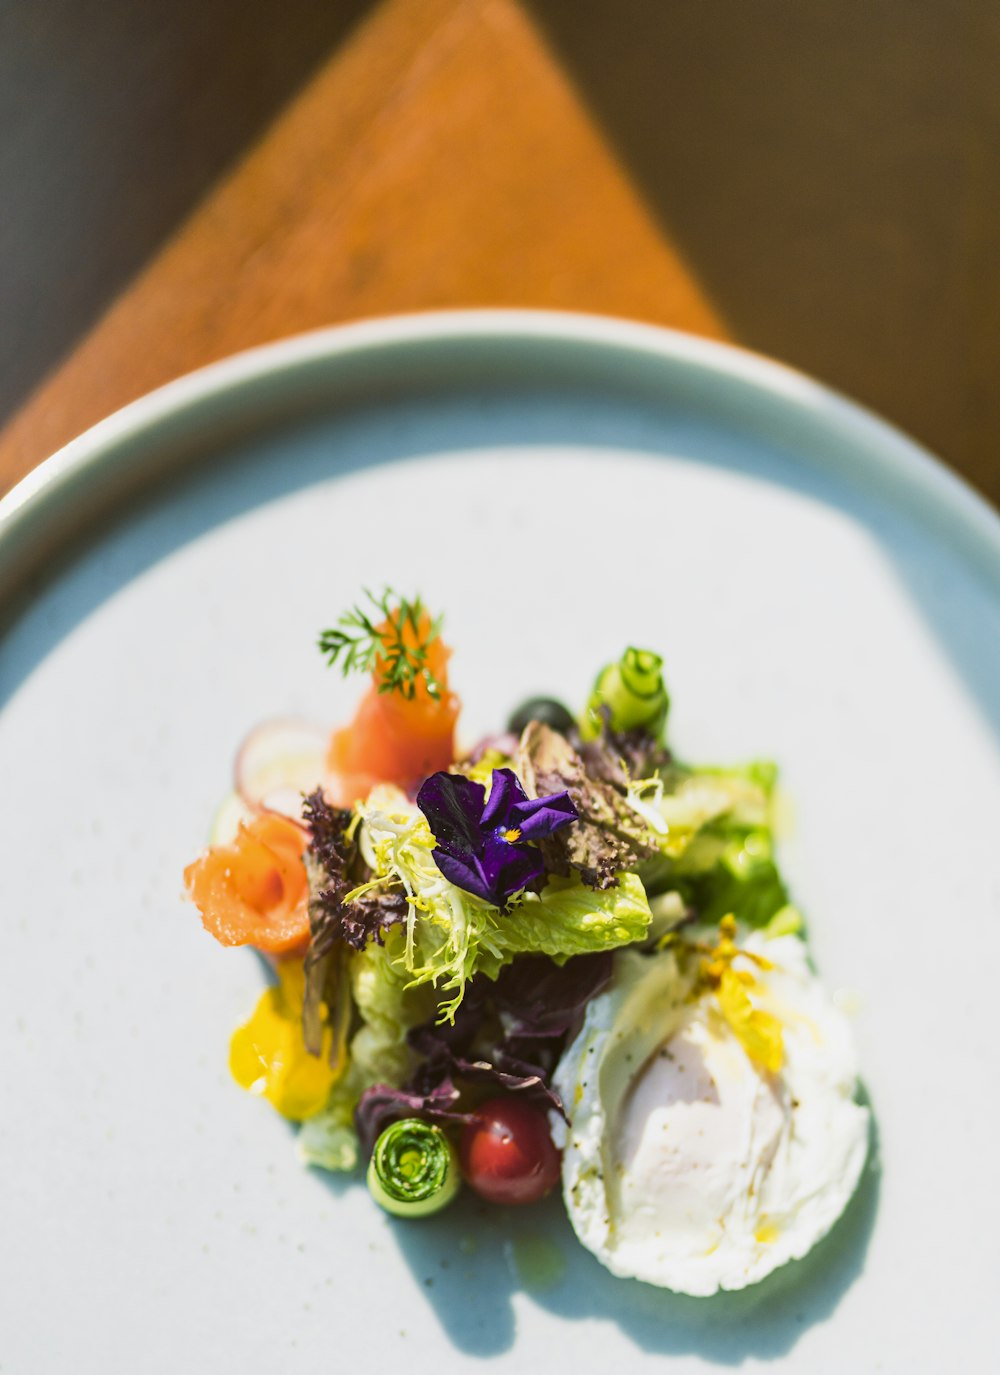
[0,308,1000,604]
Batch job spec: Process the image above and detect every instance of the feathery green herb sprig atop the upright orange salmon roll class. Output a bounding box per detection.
[319,587,443,701]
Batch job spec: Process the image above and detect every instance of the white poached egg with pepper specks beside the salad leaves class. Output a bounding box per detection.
[553,934,869,1295]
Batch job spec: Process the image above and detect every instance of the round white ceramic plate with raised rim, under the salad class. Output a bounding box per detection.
[0,314,1000,1375]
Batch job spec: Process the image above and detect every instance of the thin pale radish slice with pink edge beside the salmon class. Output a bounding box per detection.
[235,721,330,822]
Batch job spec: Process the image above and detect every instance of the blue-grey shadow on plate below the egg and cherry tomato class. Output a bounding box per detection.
[348,1099,880,1365]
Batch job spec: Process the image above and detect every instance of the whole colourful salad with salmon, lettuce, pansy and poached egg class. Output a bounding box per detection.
[184,591,869,1295]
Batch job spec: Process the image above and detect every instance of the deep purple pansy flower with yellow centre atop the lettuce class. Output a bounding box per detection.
[417,769,578,908]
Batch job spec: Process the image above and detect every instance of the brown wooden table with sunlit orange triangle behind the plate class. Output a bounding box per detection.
[0,0,1000,502]
